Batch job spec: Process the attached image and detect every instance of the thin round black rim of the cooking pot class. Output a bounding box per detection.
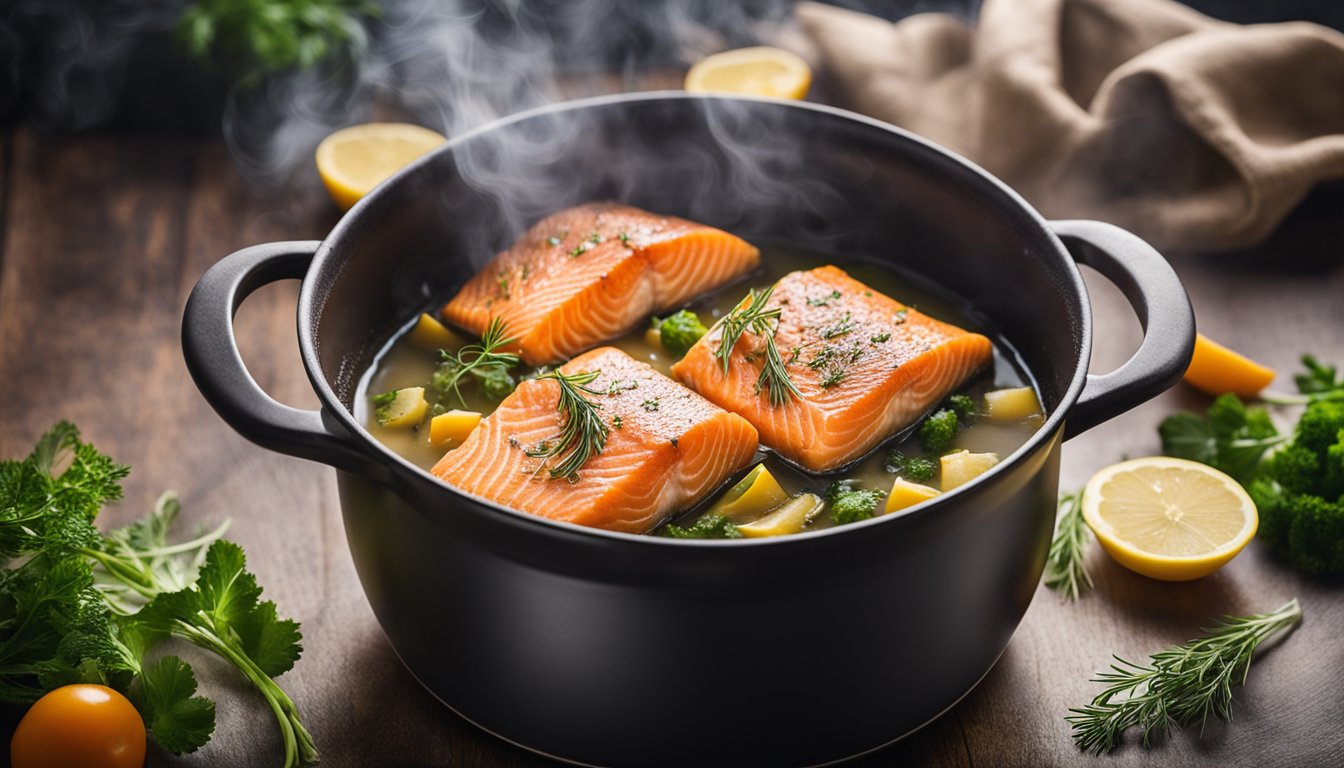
[297,90,1093,547]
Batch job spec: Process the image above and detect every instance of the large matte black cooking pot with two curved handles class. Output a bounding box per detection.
[183,93,1195,765]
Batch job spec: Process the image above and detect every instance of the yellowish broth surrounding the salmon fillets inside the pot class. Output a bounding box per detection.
[355,245,1040,533]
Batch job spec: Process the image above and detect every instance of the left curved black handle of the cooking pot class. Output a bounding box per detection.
[181,241,374,473]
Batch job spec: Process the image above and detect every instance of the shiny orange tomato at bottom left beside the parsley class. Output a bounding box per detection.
[9,685,145,768]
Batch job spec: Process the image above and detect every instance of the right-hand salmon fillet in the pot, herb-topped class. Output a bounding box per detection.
[672,266,992,472]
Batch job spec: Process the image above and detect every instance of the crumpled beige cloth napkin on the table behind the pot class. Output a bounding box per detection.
[797,0,1344,252]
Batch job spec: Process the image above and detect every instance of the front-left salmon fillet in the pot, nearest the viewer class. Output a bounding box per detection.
[433,347,757,533]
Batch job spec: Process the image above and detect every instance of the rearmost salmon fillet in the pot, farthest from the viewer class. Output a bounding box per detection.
[442,203,761,366]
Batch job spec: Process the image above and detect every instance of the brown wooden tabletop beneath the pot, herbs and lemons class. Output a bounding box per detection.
[0,121,1344,768]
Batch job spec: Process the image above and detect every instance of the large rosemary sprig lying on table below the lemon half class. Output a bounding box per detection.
[1064,599,1302,753]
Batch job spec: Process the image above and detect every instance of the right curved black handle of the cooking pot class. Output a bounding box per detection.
[1050,221,1195,440]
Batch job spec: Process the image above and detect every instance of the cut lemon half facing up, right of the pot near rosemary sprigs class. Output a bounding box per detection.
[1083,456,1259,581]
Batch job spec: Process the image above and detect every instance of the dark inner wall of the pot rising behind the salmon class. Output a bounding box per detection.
[309,94,1087,441]
